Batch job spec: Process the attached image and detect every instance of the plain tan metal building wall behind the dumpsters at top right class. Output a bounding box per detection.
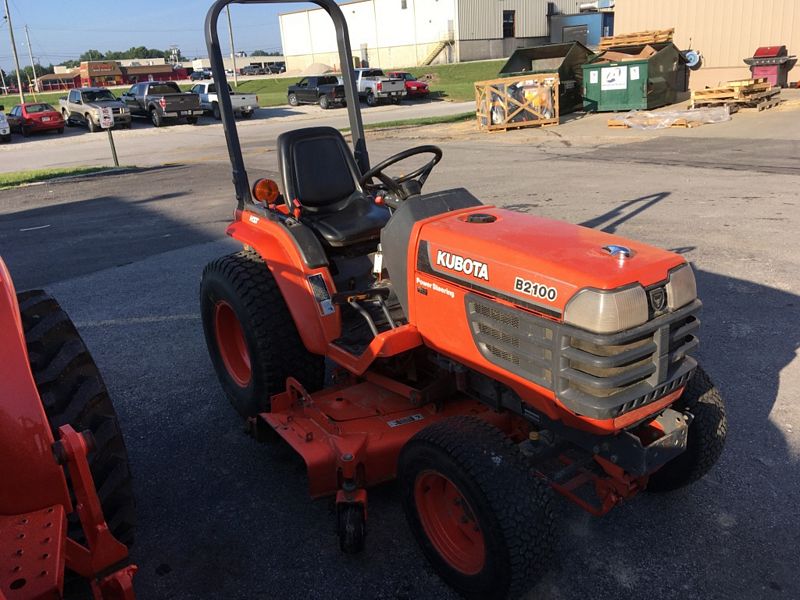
[614,0,800,88]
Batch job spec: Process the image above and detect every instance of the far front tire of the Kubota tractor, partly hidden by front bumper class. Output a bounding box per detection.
[647,367,728,492]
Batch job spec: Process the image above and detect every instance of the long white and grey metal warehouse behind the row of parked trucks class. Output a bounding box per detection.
[280,0,581,70]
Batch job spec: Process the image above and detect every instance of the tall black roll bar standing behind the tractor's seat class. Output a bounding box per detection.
[205,0,369,210]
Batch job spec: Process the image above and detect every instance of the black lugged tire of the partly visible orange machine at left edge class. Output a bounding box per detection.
[17,290,136,545]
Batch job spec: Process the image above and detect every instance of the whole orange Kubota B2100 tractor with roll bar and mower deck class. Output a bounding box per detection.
[200,0,726,598]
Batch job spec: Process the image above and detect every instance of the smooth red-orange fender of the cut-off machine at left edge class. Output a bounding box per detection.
[0,259,71,515]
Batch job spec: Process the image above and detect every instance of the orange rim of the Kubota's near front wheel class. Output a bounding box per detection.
[414,471,486,575]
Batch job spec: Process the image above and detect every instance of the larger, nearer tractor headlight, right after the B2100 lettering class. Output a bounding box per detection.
[564,285,647,333]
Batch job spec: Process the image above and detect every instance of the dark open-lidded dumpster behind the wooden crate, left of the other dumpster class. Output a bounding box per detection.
[500,42,593,115]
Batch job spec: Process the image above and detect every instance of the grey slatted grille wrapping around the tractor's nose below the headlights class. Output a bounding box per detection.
[467,294,700,419]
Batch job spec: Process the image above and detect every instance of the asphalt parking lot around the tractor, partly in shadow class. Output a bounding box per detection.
[0,102,800,599]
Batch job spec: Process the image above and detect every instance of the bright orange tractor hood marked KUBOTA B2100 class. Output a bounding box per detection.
[416,206,685,317]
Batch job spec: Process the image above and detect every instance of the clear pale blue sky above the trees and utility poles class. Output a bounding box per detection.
[0,0,322,71]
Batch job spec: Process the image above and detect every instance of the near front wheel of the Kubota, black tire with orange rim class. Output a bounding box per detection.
[398,417,556,600]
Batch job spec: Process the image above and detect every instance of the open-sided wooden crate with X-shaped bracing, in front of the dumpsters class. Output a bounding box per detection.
[475,73,559,131]
